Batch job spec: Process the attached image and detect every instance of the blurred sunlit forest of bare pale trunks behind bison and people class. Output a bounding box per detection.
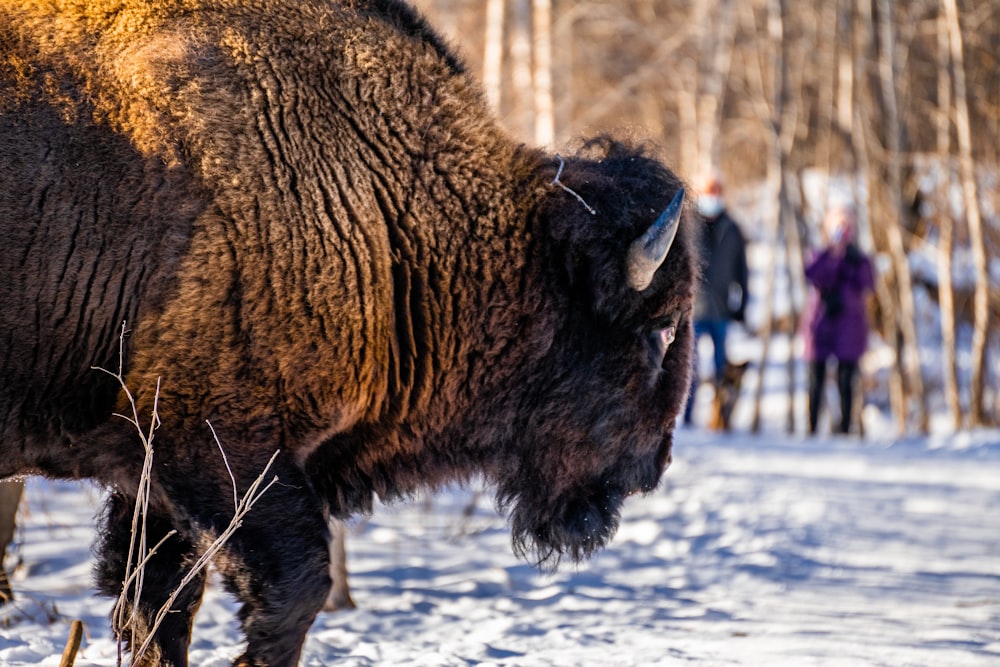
[416,0,1000,433]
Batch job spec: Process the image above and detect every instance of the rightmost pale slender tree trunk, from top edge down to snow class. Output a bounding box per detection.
[942,0,990,426]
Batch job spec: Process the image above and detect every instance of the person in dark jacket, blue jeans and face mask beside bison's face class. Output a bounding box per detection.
[684,173,748,424]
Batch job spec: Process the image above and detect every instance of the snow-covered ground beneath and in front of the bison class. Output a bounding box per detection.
[0,428,1000,667]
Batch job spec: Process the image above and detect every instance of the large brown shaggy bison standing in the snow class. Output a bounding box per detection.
[0,0,697,666]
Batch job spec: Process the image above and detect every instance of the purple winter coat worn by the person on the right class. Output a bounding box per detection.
[804,245,875,361]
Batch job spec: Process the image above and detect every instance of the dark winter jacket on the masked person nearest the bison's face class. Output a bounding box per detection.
[694,211,747,321]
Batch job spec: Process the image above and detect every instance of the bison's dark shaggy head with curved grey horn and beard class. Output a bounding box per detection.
[491,140,697,565]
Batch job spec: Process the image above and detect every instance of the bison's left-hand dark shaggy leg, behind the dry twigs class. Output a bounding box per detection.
[97,493,205,667]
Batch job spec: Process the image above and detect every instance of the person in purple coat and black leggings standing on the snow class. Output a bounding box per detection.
[803,206,875,434]
